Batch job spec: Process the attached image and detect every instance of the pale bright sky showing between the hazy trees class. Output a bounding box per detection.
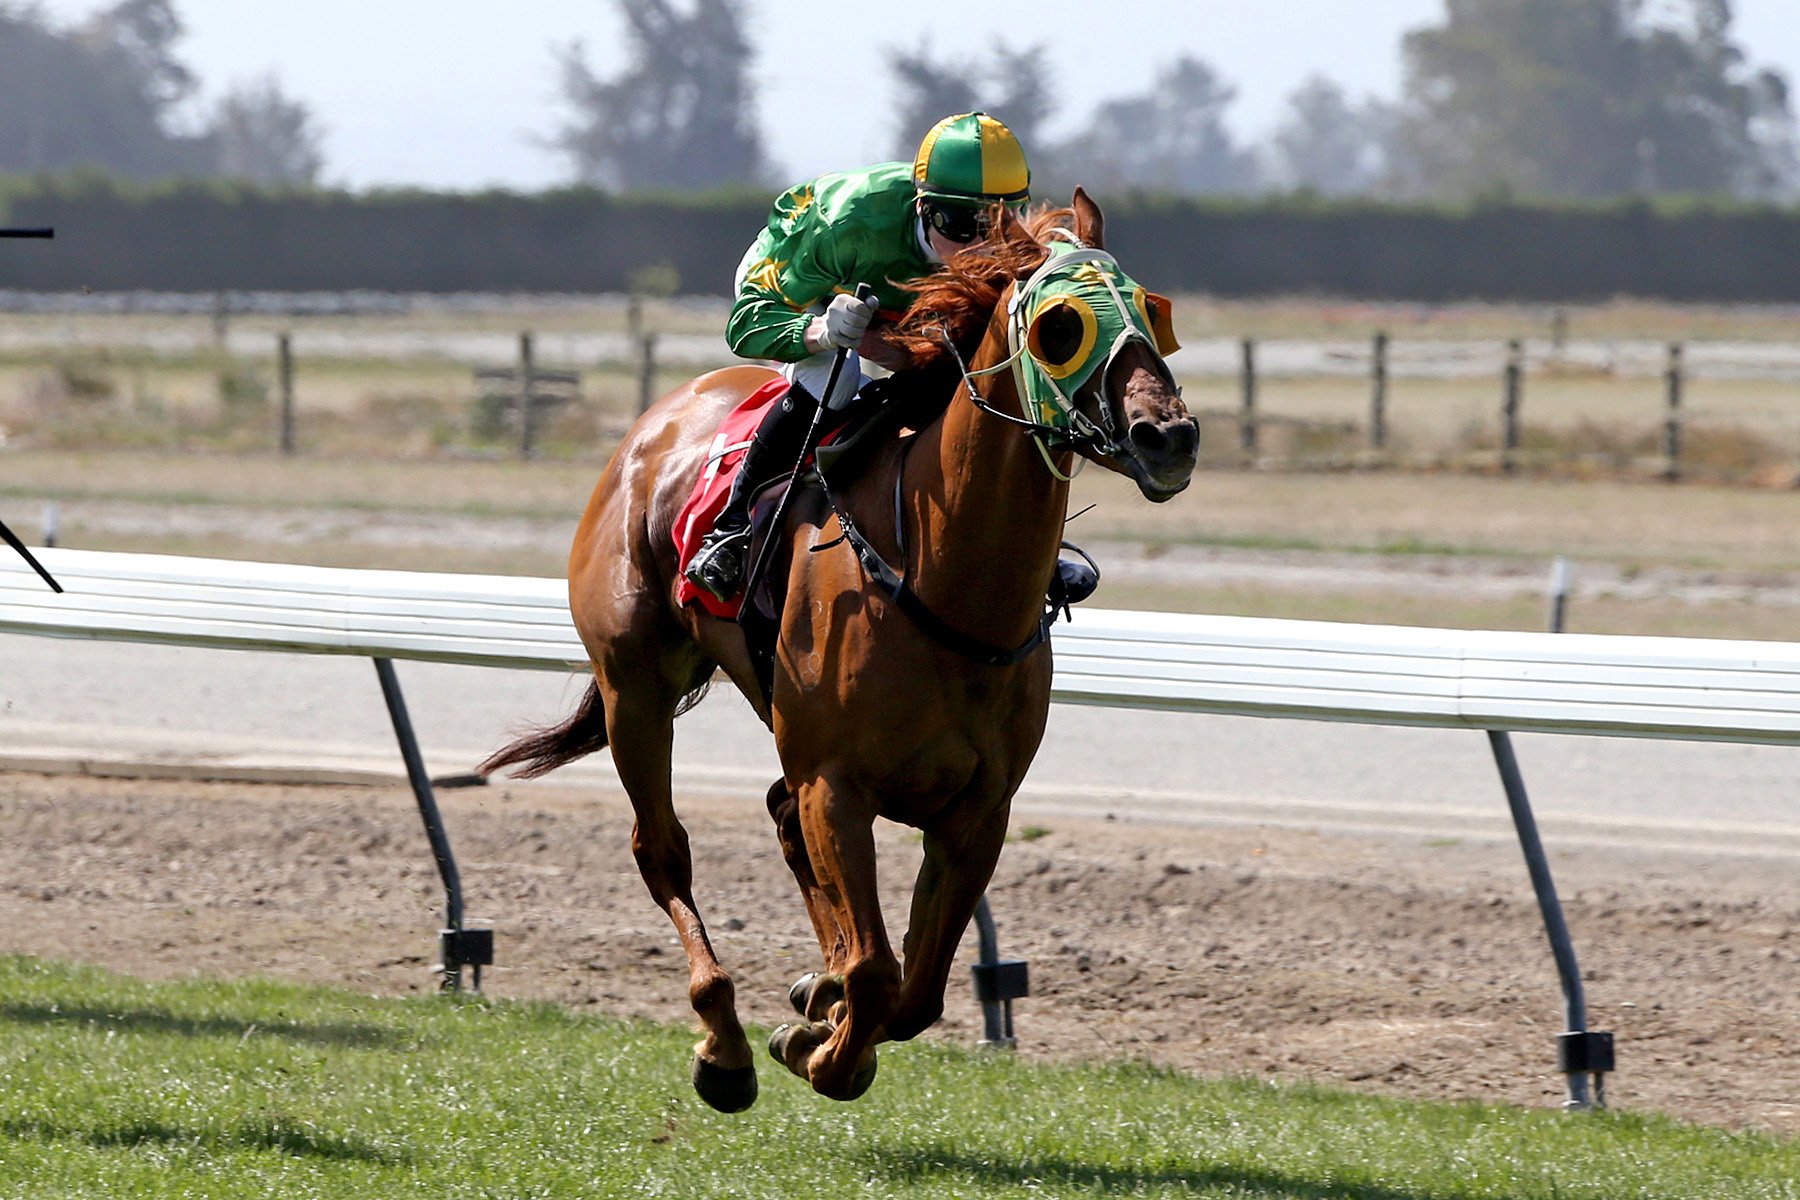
[38,0,1800,191]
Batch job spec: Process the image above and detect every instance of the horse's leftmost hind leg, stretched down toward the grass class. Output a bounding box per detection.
[601,671,756,1112]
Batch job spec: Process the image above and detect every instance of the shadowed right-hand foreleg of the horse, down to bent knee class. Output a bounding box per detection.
[887,804,1008,1042]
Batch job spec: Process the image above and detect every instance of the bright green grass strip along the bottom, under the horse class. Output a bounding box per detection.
[0,957,1800,1200]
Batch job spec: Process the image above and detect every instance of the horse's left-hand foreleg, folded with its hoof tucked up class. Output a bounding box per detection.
[769,779,900,1099]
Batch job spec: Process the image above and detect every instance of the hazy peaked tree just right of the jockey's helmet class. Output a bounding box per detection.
[1057,54,1260,193]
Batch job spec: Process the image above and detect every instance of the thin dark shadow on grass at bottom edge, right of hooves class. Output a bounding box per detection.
[871,1146,1476,1200]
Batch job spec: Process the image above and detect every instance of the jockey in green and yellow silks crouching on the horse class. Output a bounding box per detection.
[688,112,1031,599]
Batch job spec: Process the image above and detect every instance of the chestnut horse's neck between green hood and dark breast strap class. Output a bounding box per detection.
[907,308,1069,644]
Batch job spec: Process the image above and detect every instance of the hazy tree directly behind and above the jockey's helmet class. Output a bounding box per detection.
[887,43,1051,164]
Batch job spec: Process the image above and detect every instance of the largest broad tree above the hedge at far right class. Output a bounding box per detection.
[1395,0,1793,196]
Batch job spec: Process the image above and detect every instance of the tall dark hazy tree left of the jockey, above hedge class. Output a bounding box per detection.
[549,0,767,191]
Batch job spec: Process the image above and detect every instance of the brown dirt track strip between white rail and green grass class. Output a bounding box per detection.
[0,775,1800,1137]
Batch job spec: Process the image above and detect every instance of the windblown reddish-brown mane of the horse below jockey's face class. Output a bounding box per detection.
[886,205,1075,369]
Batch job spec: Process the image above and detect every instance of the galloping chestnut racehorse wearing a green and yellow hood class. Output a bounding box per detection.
[481,189,1199,1112]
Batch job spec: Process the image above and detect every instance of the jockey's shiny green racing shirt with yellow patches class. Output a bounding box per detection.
[725,162,934,362]
